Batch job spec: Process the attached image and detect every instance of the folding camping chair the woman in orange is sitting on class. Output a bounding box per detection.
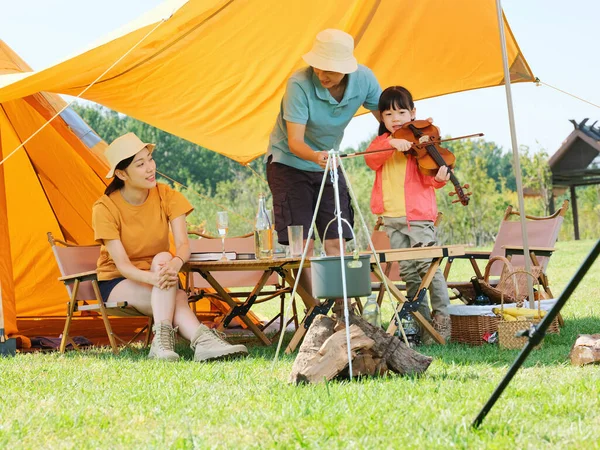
[48,233,152,354]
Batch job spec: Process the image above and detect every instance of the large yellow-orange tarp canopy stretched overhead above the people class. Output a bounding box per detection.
[0,0,534,163]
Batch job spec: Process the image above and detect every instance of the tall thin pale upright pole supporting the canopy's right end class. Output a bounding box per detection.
[496,0,535,308]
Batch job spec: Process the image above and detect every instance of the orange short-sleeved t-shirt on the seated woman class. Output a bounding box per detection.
[92,183,194,281]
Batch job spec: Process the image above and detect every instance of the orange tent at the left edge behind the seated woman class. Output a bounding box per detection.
[0,40,107,335]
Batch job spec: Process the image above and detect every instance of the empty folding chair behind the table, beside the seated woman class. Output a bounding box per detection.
[186,230,298,340]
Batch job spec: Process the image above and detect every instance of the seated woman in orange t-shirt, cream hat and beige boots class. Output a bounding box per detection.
[92,133,248,361]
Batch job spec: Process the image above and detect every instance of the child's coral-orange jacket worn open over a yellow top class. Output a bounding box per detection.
[365,133,446,223]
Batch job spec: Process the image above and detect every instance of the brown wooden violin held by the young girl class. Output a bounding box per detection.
[392,120,472,206]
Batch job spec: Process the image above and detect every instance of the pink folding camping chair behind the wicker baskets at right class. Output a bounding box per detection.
[444,200,569,301]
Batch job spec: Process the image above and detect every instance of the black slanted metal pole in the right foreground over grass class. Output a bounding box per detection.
[471,239,600,428]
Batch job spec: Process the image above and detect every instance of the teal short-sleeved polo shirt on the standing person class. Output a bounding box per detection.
[267,65,381,172]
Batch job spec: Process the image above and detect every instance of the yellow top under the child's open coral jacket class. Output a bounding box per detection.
[381,152,407,217]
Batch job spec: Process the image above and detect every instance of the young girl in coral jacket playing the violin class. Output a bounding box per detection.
[365,86,450,341]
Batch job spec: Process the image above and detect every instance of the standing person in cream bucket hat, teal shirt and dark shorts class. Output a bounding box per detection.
[267,29,381,316]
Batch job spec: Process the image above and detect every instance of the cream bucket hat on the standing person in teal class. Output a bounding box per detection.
[302,28,358,73]
